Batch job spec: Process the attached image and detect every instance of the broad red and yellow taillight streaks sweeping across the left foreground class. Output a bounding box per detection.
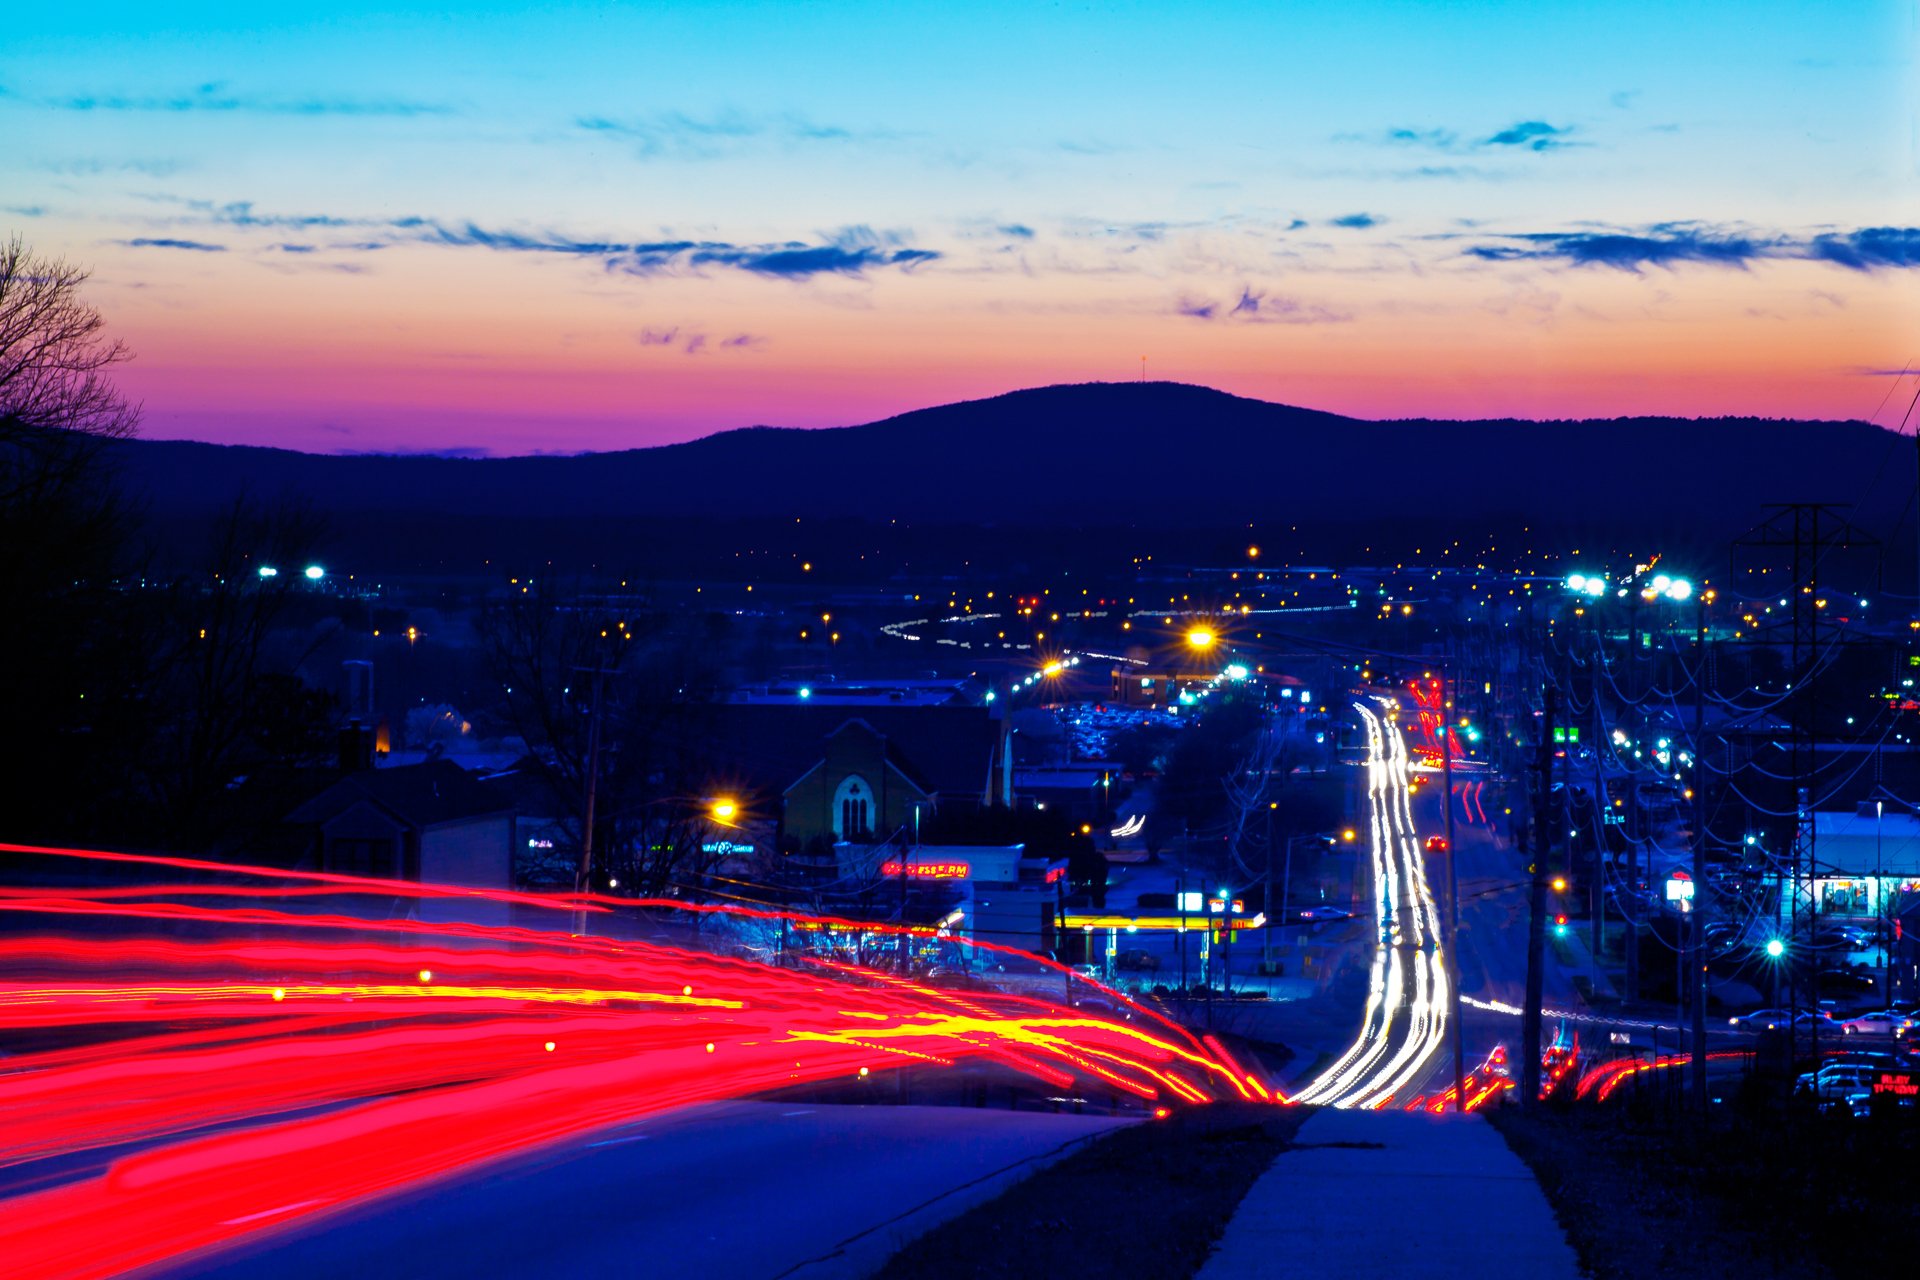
[0,844,1284,1280]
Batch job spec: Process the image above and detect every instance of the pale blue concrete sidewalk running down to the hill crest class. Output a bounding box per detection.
[1200,1109,1580,1280]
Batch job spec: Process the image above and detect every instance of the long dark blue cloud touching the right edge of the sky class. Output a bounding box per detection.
[1465,223,1920,274]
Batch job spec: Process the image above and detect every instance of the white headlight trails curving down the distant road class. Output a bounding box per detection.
[1294,702,1450,1107]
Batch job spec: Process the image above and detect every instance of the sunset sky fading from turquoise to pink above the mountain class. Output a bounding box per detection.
[0,0,1920,455]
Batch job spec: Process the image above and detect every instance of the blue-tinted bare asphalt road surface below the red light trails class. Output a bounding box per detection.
[168,1102,1125,1280]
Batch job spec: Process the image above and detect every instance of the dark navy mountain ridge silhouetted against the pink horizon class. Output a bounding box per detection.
[105,382,1914,571]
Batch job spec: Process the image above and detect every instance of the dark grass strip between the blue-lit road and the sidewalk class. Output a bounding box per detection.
[879,1103,1311,1280]
